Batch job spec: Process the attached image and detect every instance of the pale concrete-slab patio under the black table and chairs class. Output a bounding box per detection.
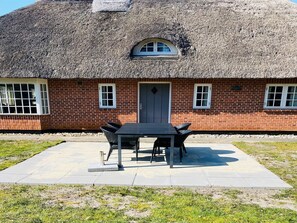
[0,142,291,189]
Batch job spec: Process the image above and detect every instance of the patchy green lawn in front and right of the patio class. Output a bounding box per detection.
[0,142,297,223]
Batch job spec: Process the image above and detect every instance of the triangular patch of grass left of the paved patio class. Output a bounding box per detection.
[0,140,61,171]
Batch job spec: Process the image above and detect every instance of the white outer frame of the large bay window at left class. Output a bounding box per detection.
[0,78,50,115]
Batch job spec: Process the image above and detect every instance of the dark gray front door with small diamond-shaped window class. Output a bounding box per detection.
[139,84,170,123]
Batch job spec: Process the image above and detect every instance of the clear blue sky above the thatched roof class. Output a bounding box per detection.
[0,0,297,16]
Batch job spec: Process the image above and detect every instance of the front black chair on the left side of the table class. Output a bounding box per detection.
[100,126,139,161]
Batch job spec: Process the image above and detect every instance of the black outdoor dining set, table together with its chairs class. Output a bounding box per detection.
[100,122,192,168]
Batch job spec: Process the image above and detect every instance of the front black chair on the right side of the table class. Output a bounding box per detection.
[151,130,192,162]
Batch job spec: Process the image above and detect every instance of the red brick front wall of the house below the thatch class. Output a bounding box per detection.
[0,78,297,131]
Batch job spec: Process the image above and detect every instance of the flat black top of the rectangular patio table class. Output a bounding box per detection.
[115,123,177,136]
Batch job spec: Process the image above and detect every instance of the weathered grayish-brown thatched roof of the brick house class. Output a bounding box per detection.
[0,0,297,78]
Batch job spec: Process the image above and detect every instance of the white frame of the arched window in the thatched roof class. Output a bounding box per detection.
[132,38,178,57]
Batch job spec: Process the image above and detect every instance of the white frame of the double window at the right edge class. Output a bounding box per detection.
[264,84,297,110]
